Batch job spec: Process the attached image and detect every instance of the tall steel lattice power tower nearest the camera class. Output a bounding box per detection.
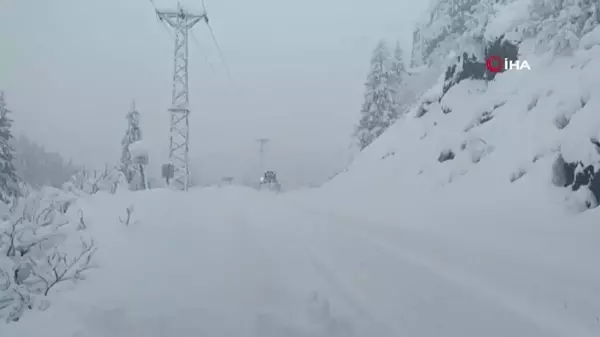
[156,5,208,191]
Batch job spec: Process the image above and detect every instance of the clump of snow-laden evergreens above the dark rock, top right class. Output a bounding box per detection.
[411,0,600,67]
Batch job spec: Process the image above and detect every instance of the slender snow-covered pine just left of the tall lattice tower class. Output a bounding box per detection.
[121,102,142,190]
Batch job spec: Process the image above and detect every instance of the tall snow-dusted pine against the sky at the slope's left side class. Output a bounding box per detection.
[355,41,397,150]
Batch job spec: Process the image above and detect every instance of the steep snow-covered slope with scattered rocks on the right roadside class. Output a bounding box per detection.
[321,27,600,209]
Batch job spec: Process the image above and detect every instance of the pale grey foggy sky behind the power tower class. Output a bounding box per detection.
[0,0,427,185]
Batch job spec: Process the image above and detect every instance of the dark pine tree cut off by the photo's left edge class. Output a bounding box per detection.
[0,91,21,204]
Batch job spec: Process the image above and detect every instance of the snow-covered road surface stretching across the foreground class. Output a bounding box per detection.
[8,189,600,337]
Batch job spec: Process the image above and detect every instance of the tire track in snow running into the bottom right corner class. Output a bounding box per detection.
[298,205,598,337]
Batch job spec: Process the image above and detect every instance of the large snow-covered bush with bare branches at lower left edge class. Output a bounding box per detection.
[0,188,96,324]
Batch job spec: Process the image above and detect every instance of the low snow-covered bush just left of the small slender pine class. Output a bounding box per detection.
[63,165,127,194]
